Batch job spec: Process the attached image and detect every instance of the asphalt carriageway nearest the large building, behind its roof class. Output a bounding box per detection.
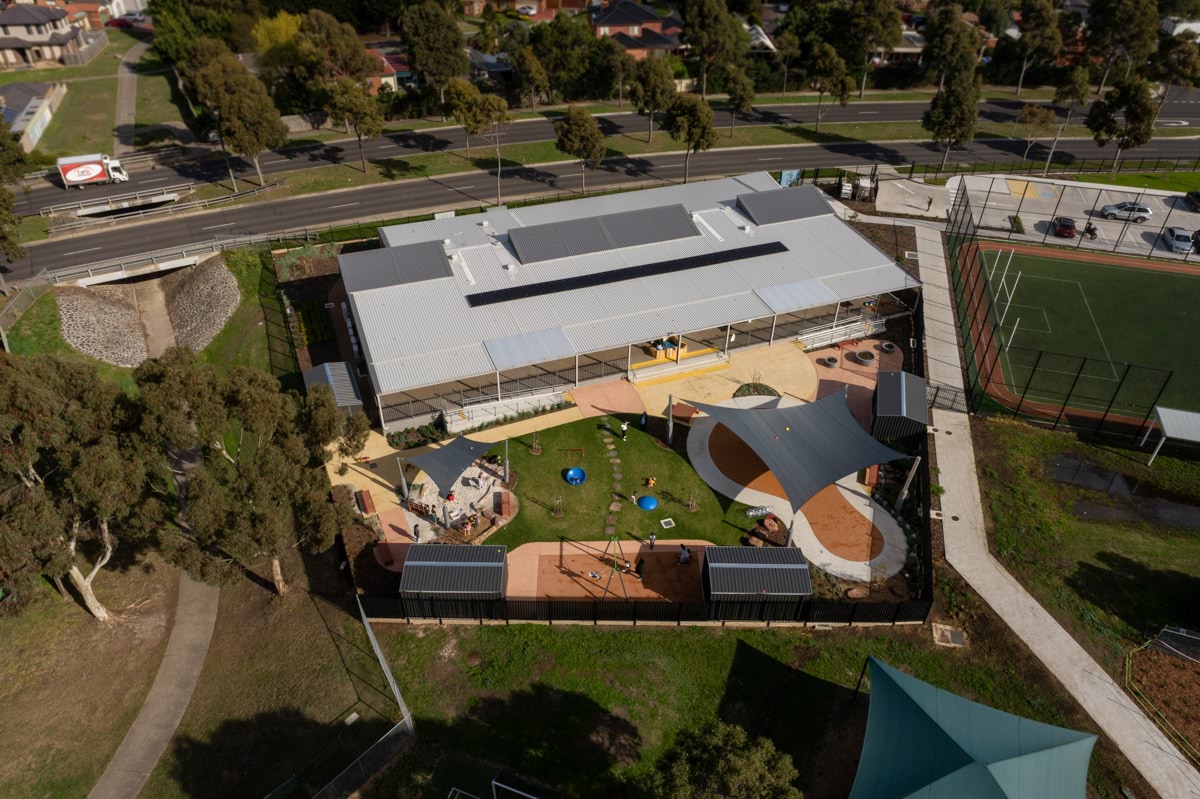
[14,139,1196,280]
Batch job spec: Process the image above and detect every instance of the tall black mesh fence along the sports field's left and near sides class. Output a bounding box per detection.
[946,186,1174,440]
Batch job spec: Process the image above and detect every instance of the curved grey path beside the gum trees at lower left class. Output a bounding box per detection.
[88,573,220,799]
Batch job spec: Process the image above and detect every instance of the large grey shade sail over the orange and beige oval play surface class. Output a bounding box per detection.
[685,391,906,511]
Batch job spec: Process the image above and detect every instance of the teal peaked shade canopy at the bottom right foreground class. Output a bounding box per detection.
[850,657,1096,799]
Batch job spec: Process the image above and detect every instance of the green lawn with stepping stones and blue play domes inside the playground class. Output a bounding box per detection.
[487,416,754,548]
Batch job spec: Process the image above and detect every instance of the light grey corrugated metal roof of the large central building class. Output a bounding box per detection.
[340,173,919,394]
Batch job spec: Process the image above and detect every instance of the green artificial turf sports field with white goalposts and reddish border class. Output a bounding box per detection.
[978,242,1200,415]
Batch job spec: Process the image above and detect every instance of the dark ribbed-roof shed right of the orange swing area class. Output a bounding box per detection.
[704,547,812,602]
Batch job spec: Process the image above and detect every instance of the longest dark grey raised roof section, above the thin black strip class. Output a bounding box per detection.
[509,204,700,264]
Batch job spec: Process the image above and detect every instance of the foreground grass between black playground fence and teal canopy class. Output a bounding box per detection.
[367,625,1142,799]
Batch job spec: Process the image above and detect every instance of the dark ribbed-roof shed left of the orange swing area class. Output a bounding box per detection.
[400,543,508,600]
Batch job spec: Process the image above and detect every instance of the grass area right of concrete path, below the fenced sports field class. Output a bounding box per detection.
[974,420,1200,675]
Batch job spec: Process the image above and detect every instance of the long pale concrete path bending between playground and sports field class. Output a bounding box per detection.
[907,220,1200,799]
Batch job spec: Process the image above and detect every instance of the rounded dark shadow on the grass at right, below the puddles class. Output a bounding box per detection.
[1066,552,1200,632]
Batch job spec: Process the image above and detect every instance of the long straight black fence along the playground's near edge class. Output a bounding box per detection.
[362,596,932,626]
